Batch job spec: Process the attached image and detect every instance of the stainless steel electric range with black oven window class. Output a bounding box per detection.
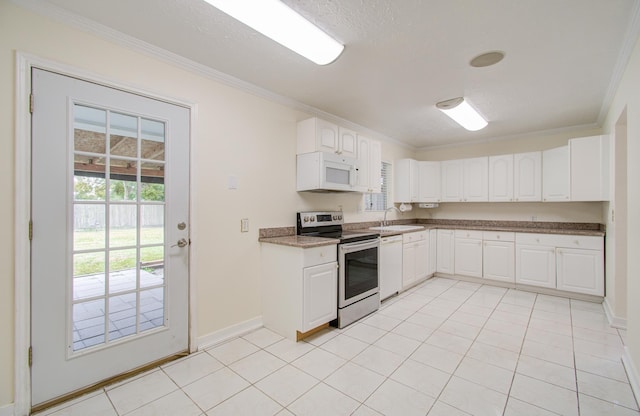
[296,211,380,328]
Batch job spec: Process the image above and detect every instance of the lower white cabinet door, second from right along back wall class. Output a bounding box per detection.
[516,244,556,289]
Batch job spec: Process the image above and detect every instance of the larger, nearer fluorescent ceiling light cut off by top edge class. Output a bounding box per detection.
[205,0,344,65]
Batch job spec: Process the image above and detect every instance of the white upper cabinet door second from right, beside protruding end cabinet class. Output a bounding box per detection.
[542,146,571,202]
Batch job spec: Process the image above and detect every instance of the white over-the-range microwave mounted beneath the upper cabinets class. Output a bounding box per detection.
[297,152,359,192]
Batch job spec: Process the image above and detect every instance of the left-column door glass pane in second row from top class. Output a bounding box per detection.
[73,154,107,201]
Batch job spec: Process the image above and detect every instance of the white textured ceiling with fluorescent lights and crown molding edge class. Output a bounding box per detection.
[33,0,639,147]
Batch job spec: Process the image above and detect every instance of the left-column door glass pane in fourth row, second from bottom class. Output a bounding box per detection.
[73,251,106,300]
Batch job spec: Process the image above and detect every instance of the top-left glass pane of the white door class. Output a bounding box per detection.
[73,104,107,154]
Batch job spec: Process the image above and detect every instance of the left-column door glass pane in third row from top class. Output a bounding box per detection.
[73,204,106,251]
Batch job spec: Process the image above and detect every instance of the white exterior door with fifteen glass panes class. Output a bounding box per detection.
[31,69,190,406]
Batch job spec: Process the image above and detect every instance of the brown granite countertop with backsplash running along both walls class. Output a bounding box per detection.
[258,219,605,248]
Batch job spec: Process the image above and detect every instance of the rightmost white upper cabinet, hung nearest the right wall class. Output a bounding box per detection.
[569,136,609,201]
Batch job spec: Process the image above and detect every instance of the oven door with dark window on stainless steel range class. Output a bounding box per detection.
[338,238,380,308]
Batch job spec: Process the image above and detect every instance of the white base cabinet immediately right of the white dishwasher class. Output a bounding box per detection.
[402,231,429,289]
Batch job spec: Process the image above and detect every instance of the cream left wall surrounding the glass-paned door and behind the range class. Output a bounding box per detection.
[0,0,411,408]
